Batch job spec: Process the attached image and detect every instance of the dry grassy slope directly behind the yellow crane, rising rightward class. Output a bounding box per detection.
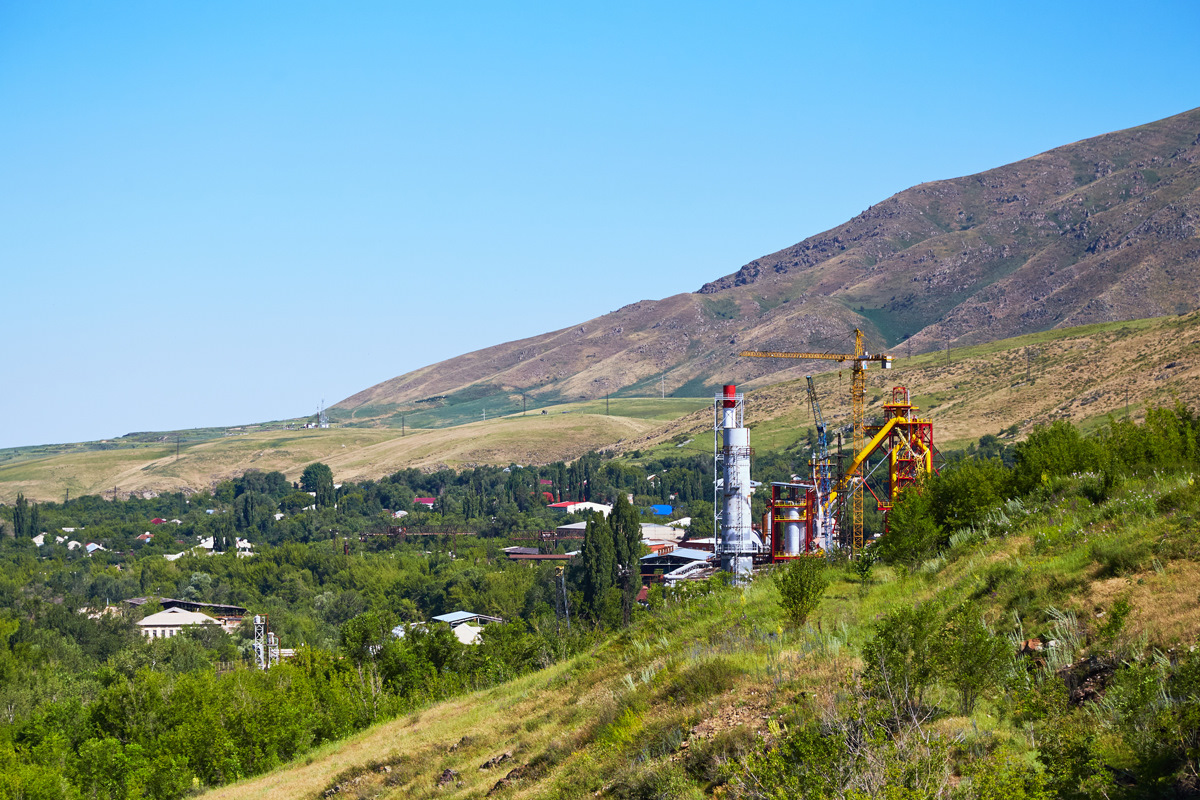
[623,312,1200,455]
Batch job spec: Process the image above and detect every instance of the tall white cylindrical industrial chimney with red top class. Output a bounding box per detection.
[713,384,762,583]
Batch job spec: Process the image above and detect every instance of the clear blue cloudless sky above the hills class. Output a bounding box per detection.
[0,0,1200,446]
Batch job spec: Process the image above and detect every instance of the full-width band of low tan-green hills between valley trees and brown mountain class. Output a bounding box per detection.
[0,312,1200,501]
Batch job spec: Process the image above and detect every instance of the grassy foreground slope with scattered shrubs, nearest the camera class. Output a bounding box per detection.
[204,465,1200,800]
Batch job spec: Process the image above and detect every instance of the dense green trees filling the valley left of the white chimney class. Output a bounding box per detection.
[0,453,712,798]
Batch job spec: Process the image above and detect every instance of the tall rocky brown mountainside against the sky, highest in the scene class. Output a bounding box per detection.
[335,109,1200,425]
